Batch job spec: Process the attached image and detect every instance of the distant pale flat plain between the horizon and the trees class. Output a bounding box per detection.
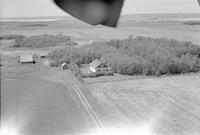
[0,14,200,45]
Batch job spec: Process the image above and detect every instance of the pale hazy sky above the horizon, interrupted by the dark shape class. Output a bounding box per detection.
[0,0,200,17]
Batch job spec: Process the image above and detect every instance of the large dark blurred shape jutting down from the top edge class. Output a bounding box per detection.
[54,0,124,27]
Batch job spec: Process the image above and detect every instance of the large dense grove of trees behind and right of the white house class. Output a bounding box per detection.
[49,36,200,76]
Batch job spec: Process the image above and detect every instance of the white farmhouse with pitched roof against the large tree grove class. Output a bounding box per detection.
[90,59,111,72]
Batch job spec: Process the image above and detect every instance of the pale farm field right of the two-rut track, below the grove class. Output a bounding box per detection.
[84,74,200,135]
